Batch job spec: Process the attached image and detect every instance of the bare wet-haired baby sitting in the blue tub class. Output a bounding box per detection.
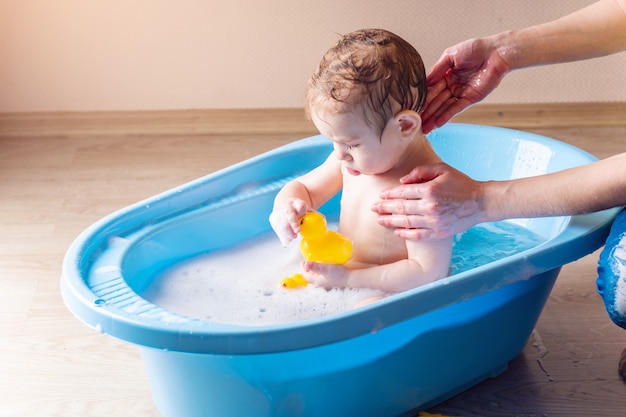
[271,29,452,292]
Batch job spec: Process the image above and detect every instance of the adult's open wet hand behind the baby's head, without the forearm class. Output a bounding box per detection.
[422,38,511,133]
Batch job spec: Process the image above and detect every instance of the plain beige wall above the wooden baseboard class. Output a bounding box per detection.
[0,0,626,112]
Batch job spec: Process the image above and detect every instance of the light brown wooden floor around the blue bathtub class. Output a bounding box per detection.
[0,110,626,417]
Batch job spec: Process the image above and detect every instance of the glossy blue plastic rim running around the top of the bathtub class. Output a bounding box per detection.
[61,124,619,354]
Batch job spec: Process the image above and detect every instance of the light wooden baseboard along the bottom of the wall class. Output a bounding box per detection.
[0,102,626,137]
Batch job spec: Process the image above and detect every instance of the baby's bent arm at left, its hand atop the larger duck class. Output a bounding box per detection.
[270,153,342,246]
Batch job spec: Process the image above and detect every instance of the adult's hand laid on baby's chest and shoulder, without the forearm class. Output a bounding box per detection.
[372,163,486,240]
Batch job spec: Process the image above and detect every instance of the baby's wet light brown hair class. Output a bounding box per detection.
[305,29,427,133]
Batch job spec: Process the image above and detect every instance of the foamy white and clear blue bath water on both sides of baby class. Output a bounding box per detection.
[141,222,542,326]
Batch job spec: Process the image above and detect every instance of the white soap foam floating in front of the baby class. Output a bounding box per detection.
[142,234,383,326]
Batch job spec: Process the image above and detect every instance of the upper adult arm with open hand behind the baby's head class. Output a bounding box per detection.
[422,0,626,133]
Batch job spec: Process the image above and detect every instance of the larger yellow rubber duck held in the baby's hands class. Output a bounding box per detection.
[300,211,352,264]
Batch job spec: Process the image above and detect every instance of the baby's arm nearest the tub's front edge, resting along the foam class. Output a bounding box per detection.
[303,238,452,293]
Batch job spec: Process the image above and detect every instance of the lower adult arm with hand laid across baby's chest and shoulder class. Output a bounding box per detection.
[372,153,626,240]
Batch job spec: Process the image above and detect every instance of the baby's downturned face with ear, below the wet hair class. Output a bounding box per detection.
[311,106,404,175]
